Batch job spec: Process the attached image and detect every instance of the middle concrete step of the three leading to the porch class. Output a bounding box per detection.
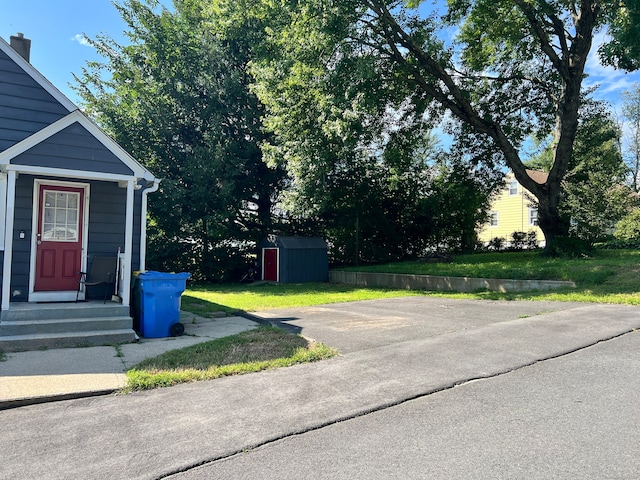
[0,316,133,337]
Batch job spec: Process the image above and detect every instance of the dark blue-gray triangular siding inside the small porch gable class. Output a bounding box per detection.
[11,123,133,175]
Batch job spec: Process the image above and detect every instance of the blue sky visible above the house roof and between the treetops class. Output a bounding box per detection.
[0,0,640,115]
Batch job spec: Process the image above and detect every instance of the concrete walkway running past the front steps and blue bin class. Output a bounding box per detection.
[0,312,258,410]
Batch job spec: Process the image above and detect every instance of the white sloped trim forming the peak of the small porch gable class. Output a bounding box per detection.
[0,110,155,181]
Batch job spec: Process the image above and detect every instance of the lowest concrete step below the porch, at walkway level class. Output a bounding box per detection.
[0,328,137,352]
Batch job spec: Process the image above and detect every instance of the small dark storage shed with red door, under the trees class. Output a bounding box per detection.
[258,235,329,283]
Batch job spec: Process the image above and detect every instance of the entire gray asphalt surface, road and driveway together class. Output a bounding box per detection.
[0,297,640,479]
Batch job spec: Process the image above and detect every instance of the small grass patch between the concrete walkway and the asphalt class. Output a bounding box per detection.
[123,327,338,393]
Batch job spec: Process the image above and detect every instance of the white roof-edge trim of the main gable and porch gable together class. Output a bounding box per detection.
[0,37,155,182]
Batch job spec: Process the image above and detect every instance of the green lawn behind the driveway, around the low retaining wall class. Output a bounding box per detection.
[182,250,640,315]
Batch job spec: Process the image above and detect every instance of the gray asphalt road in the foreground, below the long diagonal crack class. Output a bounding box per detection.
[171,333,640,480]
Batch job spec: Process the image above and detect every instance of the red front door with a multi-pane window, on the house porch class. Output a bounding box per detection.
[34,185,84,291]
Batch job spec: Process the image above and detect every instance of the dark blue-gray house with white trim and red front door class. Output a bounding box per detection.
[0,34,159,348]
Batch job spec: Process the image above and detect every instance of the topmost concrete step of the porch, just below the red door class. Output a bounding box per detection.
[1,302,129,322]
